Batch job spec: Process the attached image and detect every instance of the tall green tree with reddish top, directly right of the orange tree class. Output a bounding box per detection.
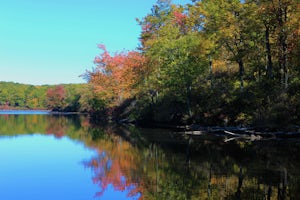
[140,1,208,115]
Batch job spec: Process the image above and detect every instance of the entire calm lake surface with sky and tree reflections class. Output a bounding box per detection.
[0,111,300,200]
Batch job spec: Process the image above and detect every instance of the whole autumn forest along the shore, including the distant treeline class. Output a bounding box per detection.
[0,0,300,130]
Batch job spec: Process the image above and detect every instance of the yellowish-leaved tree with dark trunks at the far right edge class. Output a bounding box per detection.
[247,0,299,89]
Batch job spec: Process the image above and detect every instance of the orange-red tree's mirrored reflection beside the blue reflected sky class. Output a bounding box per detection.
[85,126,143,197]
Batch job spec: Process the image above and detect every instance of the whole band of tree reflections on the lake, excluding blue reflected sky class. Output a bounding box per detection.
[0,115,300,199]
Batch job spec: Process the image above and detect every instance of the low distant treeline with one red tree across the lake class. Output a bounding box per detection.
[0,82,101,112]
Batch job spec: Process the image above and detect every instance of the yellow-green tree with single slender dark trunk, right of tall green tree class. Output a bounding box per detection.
[199,0,257,90]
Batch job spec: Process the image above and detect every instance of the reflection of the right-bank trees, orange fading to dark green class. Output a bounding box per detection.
[87,128,300,199]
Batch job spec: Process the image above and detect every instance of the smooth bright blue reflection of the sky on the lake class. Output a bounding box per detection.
[0,134,140,200]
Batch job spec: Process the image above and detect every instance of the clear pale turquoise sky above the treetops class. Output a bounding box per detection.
[0,0,190,85]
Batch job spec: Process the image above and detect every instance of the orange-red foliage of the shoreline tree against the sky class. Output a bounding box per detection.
[86,44,144,106]
